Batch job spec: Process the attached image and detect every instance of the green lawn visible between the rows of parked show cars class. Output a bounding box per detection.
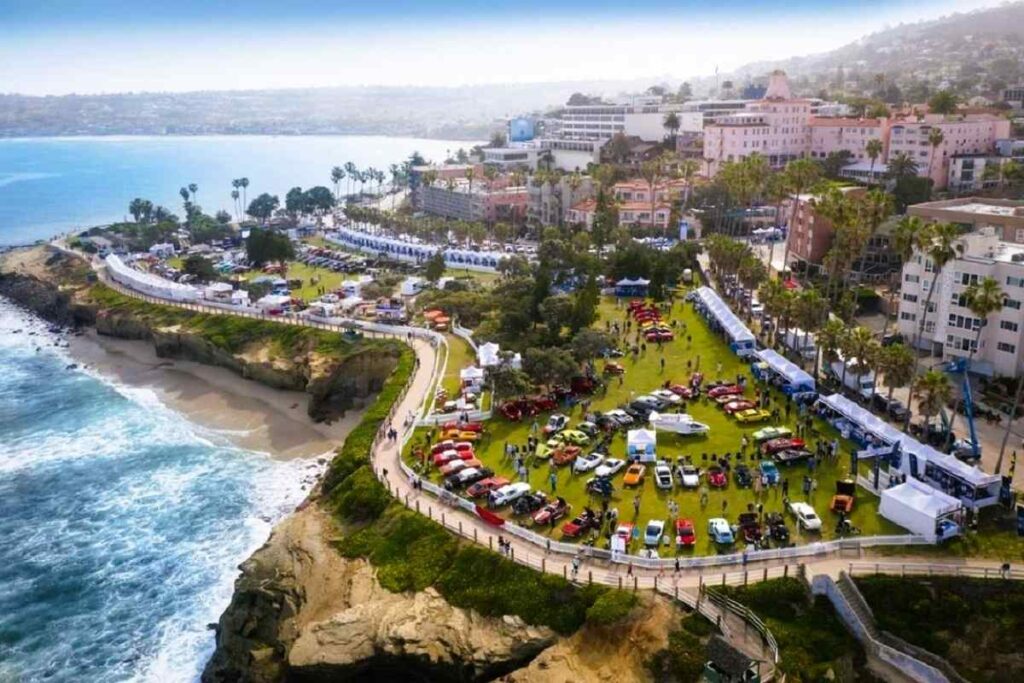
[407,299,900,556]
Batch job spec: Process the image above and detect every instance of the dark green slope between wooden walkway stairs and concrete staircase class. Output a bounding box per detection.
[714,579,864,681]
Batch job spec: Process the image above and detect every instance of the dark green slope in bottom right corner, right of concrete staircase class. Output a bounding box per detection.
[855,575,1024,683]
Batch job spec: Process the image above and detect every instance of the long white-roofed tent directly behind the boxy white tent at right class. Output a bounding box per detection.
[818,393,1000,508]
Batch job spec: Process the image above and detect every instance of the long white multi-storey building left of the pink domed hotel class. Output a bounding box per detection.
[561,95,703,141]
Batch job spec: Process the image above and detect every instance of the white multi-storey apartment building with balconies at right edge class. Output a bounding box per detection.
[899,227,1024,377]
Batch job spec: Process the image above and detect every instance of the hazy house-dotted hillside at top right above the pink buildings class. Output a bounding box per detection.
[730,2,1024,101]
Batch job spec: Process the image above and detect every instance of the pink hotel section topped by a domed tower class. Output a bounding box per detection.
[703,71,812,176]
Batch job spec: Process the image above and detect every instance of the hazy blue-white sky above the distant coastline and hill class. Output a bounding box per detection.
[0,0,997,94]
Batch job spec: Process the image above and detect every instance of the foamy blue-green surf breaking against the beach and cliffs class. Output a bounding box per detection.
[0,299,316,683]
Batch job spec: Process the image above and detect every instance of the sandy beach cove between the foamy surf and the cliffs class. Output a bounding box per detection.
[71,330,361,460]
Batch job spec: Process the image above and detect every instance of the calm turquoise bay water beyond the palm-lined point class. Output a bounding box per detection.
[0,135,471,245]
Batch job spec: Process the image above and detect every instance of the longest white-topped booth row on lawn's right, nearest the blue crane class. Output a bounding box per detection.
[816,394,1000,510]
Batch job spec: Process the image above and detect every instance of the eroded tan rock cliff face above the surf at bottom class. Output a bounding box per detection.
[203,504,557,683]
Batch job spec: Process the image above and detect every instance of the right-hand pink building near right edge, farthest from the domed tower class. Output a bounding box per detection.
[888,114,1010,188]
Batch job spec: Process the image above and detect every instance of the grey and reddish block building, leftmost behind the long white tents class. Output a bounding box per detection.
[417,178,528,223]
